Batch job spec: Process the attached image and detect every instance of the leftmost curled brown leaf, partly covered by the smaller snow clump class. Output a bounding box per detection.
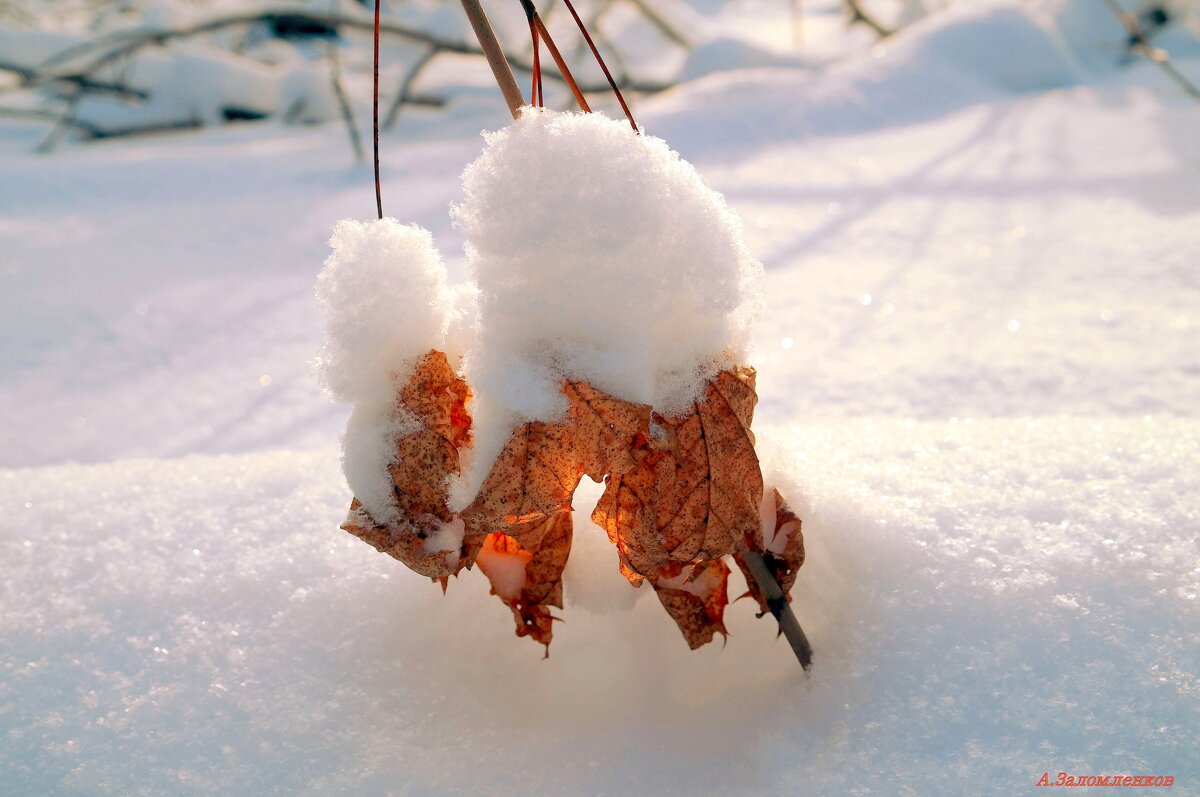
[342,350,470,579]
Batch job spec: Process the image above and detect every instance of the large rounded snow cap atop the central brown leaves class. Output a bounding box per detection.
[452,109,763,497]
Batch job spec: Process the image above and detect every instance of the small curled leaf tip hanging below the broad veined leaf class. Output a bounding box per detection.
[650,559,730,651]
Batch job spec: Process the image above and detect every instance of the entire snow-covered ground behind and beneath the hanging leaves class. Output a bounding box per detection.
[0,1,1200,797]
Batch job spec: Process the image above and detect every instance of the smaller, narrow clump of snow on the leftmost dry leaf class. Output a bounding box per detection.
[317,218,470,523]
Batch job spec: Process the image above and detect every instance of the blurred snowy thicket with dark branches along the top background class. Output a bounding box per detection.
[0,0,1200,154]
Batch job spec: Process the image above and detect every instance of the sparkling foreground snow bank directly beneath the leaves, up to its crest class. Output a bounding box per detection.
[0,418,1200,797]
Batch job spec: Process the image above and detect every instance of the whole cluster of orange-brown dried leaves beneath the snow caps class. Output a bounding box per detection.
[342,350,804,649]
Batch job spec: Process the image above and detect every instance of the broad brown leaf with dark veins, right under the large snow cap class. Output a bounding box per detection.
[592,367,762,585]
